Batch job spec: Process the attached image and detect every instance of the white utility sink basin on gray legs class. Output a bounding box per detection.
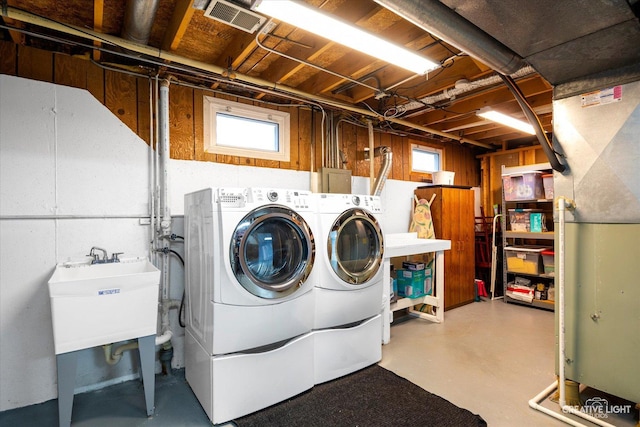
[49,258,160,354]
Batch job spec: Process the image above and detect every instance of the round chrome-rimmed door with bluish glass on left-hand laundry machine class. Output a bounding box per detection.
[230,205,315,299]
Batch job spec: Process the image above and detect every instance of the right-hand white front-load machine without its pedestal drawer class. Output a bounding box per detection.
[314,193,384,329]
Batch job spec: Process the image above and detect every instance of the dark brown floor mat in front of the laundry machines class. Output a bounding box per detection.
[234,365,487,427]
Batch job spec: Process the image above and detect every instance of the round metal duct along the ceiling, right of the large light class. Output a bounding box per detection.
[374,0,526,75]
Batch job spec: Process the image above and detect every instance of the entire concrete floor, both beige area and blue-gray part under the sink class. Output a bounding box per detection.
[0,300,636,427]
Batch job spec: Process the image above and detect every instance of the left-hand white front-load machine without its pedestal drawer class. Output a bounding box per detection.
[185,188,316,355]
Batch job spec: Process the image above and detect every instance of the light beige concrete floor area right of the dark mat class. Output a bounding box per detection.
[380,300,636,427]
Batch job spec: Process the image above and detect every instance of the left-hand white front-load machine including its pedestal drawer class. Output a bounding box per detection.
[184,188,316,424]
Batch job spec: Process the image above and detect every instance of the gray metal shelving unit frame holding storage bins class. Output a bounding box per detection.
[502,163,555,311]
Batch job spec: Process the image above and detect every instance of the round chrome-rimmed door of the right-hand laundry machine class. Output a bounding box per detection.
[327,208,383,285]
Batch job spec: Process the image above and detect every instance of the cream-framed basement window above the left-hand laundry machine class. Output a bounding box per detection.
[204,96,289,162]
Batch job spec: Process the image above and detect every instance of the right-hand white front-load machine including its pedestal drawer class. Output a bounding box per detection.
[313,194,384,384]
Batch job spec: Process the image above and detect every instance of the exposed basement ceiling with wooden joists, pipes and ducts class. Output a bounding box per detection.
[0,0,640,150]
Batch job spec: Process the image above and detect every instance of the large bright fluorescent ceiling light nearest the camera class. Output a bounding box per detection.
[253,0,440,74]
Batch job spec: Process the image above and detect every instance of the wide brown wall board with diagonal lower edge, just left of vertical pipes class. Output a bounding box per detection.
[105,70,138,133]
